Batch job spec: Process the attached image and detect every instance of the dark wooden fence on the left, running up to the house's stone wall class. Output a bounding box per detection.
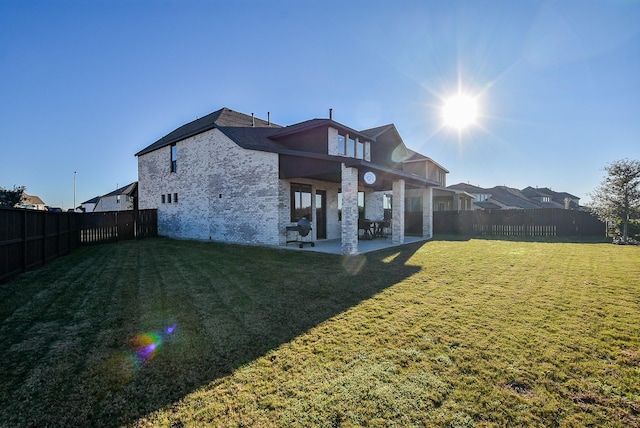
[0,207,158,281]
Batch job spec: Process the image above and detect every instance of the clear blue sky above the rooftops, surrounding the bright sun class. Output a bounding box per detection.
[0,0,640,208]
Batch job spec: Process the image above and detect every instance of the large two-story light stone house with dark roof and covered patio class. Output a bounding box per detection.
[136,108,448,254]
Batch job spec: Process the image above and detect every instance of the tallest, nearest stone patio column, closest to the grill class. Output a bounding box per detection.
[342,164,358,255]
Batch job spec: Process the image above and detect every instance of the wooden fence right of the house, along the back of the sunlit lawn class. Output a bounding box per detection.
[433,208,606,236]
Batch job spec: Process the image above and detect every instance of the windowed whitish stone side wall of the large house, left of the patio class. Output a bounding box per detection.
[138,129,282,245]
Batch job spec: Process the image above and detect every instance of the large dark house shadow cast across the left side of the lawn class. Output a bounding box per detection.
[0,239,425,427]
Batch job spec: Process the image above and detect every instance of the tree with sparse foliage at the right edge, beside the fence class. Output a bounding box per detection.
[589,159,640,241]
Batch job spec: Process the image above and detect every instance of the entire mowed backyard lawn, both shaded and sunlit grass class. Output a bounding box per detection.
[0,239,640,427]
